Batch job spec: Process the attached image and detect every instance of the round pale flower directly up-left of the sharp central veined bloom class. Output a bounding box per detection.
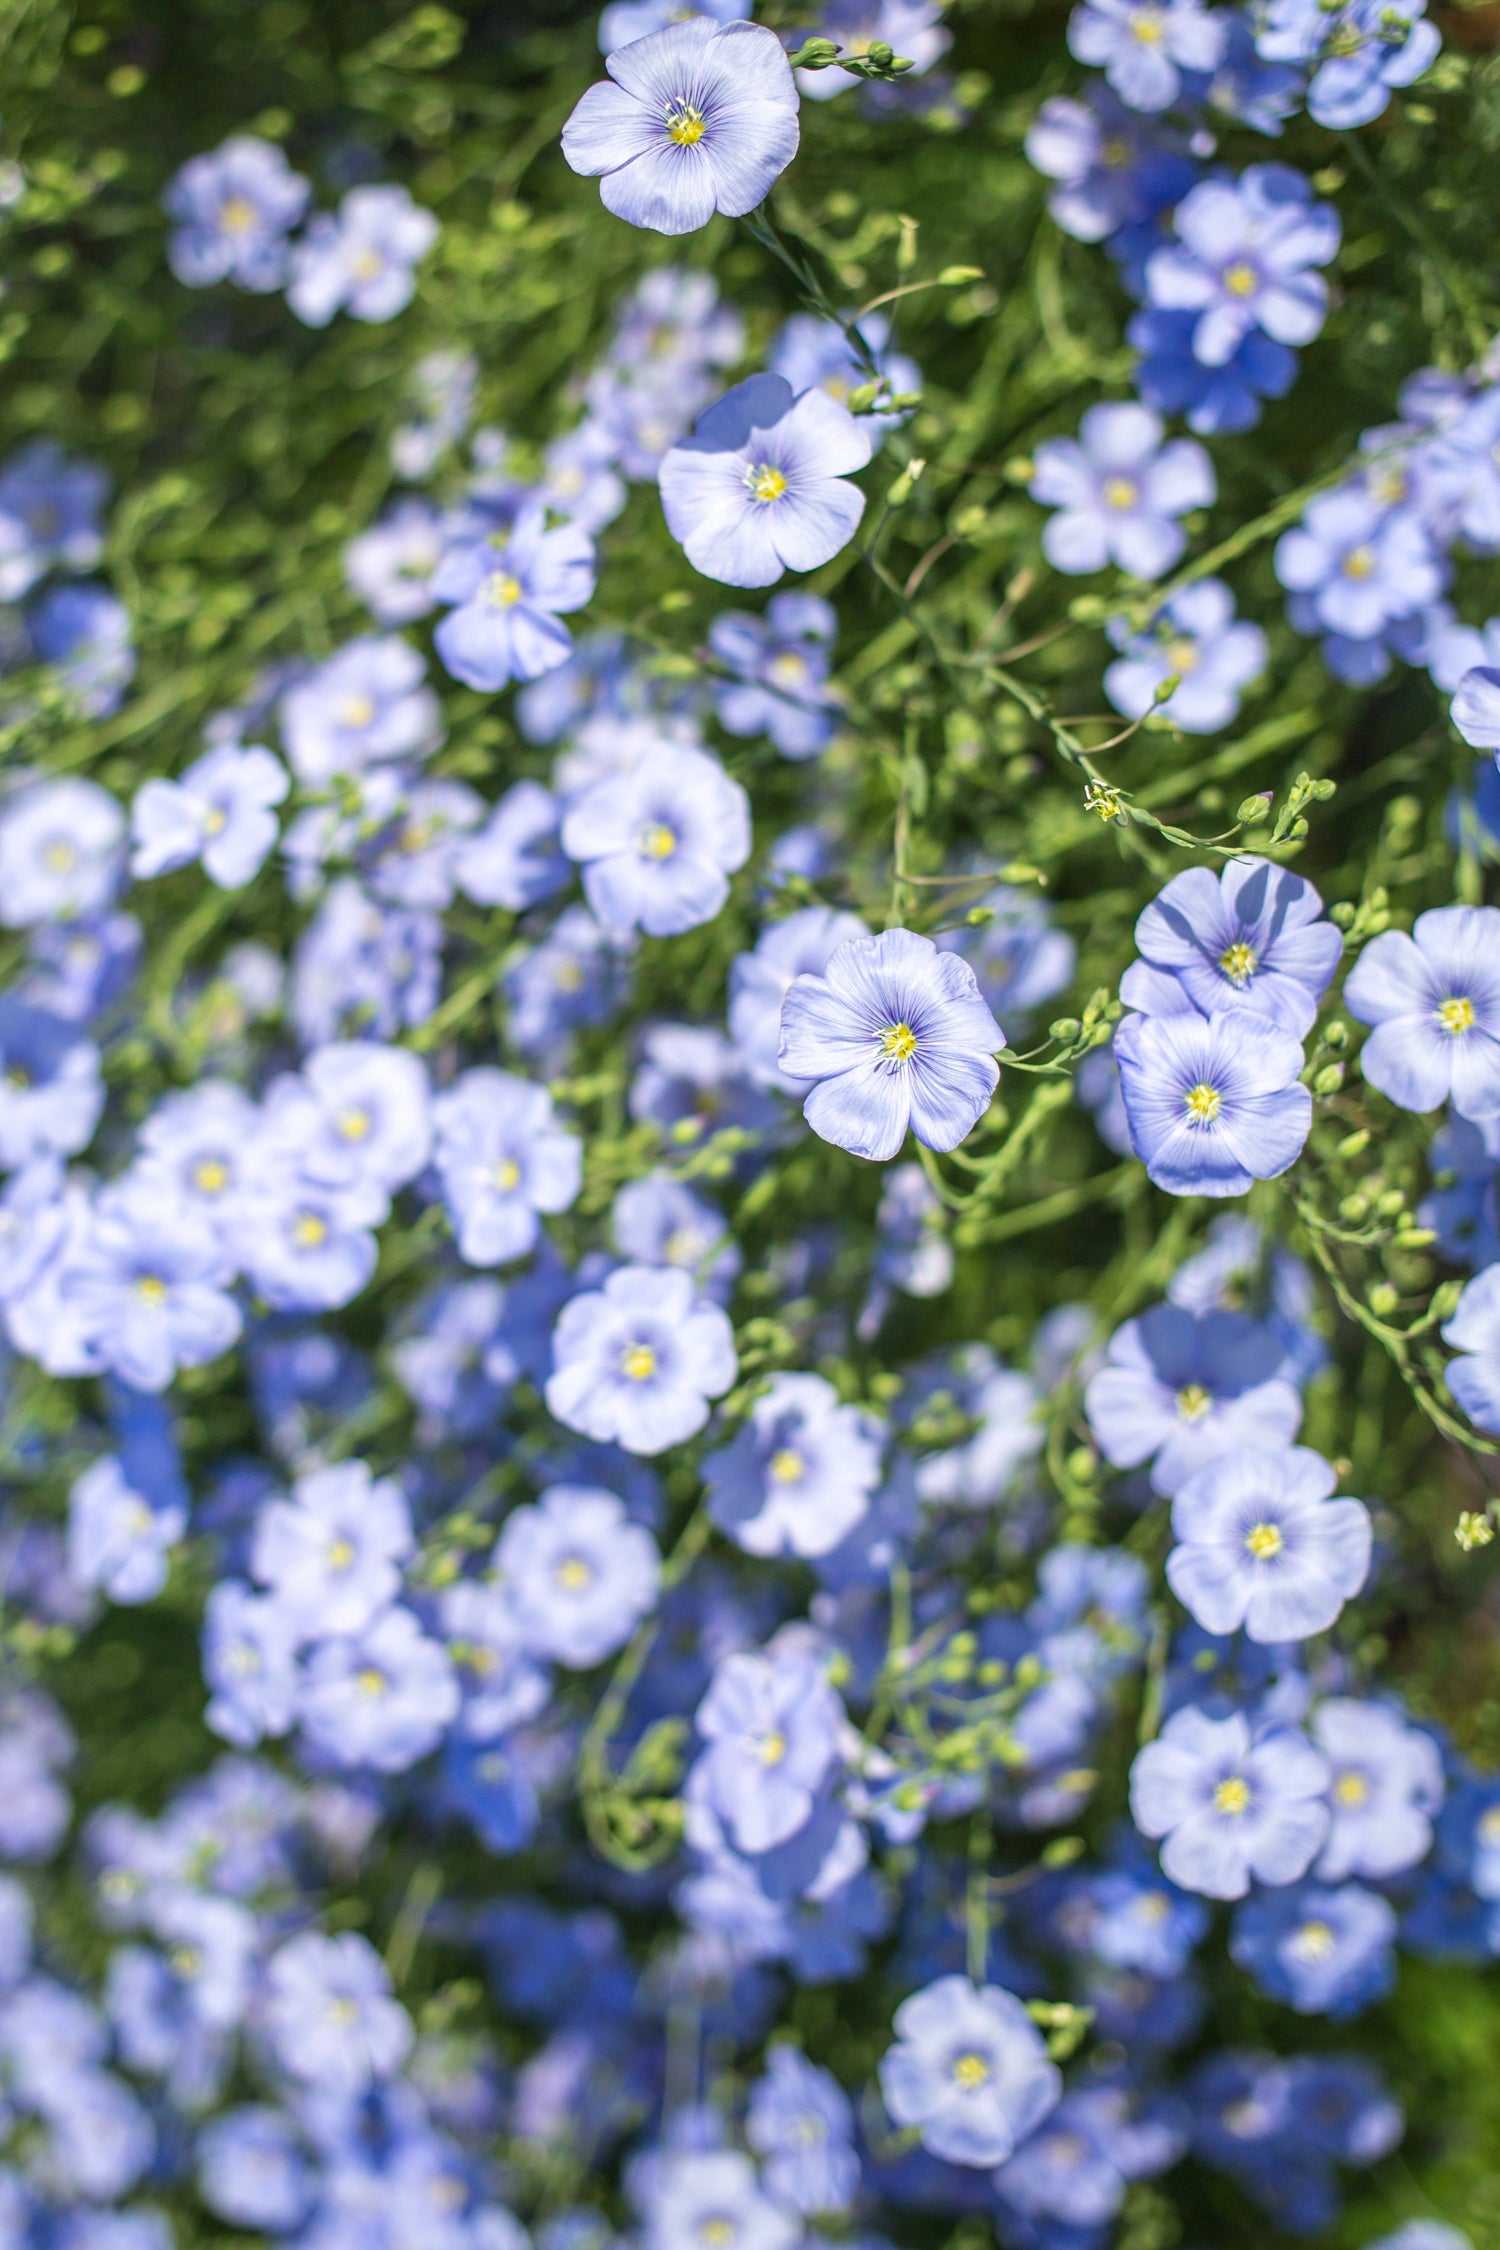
[562,747,751,938]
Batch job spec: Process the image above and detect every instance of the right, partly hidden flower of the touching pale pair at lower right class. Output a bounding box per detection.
[1311,1697,1444,1883]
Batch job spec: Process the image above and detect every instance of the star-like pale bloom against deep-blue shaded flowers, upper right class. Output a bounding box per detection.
[1147,164,1340,367]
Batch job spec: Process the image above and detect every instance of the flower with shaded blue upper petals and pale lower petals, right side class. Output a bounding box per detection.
[1084,1305,1302,1494]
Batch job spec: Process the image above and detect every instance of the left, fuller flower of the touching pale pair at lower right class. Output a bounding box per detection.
[1131,1710,1329,1899]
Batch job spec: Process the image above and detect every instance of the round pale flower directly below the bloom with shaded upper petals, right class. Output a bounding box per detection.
[1167,1445,1372,1645]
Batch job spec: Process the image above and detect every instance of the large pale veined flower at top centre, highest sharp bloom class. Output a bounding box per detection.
[562,16,798,234]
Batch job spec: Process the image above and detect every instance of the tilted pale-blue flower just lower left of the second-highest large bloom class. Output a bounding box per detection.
[432,504,594,691]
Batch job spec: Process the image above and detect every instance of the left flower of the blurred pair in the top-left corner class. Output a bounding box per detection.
[162,133,313,295]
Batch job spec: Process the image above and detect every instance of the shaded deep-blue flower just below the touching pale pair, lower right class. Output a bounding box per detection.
[1230,1883,1397,2018]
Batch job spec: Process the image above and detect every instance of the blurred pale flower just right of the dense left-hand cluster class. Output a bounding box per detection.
[432,1067,582,1265]
